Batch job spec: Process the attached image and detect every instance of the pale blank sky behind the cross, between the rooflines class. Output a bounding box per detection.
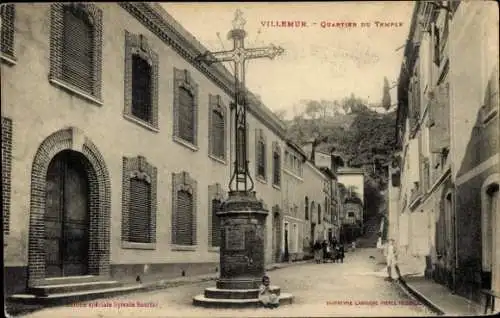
[162,1,414,116]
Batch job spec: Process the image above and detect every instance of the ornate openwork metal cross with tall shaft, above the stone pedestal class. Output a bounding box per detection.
[197,9,284,191]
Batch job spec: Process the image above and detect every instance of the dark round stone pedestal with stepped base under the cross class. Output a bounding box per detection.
[193,191,293,307]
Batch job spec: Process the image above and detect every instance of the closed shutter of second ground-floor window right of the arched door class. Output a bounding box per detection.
[174,190,194,245]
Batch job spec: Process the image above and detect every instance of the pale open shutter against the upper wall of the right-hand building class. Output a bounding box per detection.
[429,83,450,153]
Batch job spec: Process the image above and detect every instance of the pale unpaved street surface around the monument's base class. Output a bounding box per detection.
[20,248,435,317]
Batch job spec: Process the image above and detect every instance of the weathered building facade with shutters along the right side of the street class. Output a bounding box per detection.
[389,1,500,308]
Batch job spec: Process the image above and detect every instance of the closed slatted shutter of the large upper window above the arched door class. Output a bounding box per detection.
[62,7,94,94]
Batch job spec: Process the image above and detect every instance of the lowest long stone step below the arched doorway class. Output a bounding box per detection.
[8,284,143,305]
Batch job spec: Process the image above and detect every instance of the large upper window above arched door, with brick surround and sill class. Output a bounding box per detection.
[49,2,102,105]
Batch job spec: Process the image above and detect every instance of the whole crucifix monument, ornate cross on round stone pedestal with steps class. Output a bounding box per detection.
[193,10,292,307]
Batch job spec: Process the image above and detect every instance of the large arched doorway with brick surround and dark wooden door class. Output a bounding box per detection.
[28,127,111,287]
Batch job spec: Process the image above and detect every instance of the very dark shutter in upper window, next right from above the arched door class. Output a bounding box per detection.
[132,54,152,122]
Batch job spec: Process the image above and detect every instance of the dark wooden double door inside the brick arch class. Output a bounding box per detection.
[44,150,90,277]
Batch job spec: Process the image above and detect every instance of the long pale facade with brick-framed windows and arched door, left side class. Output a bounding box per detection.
[0,3,338,294]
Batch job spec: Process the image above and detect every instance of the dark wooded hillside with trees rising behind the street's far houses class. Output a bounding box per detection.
[287,94,396,219]
